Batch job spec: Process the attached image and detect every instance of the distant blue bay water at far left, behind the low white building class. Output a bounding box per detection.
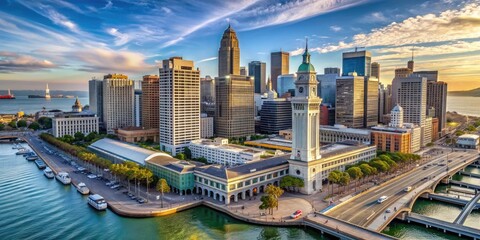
[0,96,88,114]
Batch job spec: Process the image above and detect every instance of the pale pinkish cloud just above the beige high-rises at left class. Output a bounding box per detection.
[65,47,154,73]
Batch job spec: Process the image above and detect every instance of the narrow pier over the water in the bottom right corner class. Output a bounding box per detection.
[406,213,480,240]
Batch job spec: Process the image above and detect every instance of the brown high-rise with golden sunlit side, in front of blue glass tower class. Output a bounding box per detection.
[335,73,365,128]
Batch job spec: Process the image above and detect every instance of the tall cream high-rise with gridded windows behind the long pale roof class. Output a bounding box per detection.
[159,57,200,156]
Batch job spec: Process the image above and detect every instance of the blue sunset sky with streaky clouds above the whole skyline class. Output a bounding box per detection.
[0,0,480,91]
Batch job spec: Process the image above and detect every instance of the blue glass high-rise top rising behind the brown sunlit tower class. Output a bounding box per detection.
[342,49,372,76]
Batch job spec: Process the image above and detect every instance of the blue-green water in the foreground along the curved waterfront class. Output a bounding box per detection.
[0,144,329,239]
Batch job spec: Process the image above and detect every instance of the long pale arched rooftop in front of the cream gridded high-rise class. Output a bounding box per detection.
[88,138,172,165]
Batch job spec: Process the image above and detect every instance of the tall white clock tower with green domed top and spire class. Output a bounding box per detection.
[289,41,322,194]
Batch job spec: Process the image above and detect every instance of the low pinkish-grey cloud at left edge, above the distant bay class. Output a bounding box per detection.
[0,51,58,73]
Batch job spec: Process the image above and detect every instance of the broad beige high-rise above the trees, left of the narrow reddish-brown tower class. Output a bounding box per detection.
[103,74,134,134]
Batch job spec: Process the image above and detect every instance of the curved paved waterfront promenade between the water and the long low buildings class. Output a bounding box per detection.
[10,132,393,239]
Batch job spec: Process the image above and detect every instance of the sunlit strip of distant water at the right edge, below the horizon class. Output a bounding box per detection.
[447,95,480,117]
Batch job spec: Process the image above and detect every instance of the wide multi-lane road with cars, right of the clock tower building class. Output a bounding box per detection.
[327,149,478,227]
